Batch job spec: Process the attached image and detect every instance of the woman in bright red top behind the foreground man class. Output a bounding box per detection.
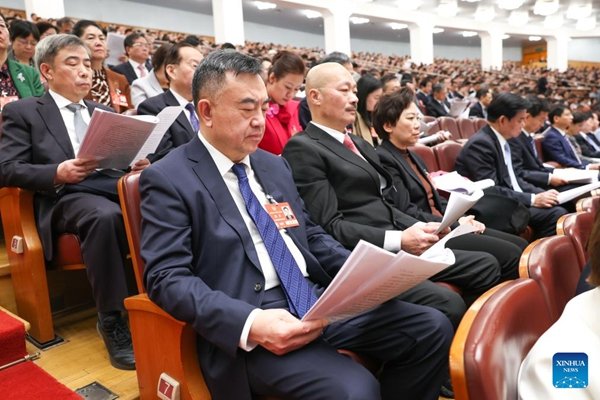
[258,51,306,155]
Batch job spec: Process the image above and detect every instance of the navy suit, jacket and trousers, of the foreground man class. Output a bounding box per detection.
[140,136,451,400]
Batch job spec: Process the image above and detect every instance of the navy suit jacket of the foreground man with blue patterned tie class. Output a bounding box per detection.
[140,137,349,400]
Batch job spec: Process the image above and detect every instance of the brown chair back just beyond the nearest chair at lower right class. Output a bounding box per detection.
[519,235,581,322]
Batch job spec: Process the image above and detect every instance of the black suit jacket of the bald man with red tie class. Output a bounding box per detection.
[282,124,419,248]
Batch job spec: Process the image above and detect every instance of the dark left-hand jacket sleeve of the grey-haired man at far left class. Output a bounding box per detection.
[0,101,58,191]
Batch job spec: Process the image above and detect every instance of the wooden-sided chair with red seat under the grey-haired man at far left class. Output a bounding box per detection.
[0,187,85,347]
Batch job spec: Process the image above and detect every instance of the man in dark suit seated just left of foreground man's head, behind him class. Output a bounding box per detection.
[138,42,202,161]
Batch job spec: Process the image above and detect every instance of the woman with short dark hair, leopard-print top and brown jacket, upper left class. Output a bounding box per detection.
[73,19,133,113]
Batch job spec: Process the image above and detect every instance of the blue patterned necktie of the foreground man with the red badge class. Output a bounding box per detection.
[231,164,317,318]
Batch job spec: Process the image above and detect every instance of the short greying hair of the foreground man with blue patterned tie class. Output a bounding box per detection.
[192,49,261,106]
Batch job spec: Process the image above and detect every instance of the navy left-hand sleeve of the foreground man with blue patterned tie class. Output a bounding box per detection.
[140,168,256,357]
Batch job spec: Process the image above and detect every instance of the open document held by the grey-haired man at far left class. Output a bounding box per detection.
[77,107,183,169]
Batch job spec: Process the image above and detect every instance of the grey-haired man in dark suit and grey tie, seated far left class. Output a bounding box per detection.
[0,34,135,369]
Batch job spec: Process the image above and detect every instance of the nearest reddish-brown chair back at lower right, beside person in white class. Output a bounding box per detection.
[450,279,552,400]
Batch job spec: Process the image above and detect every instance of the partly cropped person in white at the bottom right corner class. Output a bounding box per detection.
[518,214,600,400]
